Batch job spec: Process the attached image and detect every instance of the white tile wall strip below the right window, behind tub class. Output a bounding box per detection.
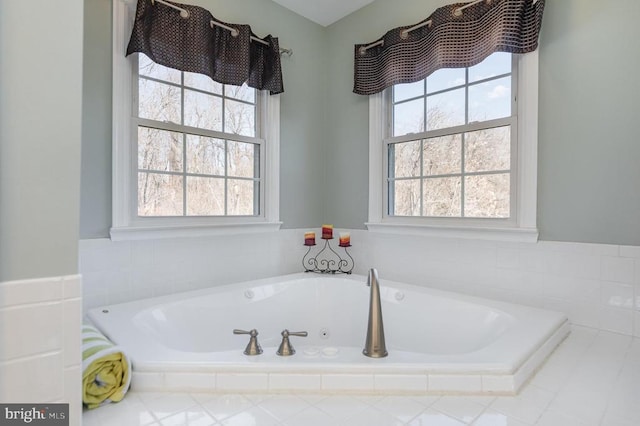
[352,231,640,336]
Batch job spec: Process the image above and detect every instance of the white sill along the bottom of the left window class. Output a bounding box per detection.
[110,222,282,241]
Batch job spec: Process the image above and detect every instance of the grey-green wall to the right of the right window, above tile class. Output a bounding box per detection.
[538,0,640,245]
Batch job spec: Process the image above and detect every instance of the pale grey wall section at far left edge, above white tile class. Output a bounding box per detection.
[0,0,83,282]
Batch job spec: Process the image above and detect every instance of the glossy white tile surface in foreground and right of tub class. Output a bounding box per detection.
[83,327,640,426]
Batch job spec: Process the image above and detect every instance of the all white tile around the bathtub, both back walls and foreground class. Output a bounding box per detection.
[80,233,640,426]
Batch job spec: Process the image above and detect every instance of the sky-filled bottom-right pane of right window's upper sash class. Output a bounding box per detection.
[469,77,511,122]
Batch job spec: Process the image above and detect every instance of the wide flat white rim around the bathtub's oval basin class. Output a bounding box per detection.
[88,273,567,374]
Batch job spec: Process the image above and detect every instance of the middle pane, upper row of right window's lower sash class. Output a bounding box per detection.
[423,134,462,176]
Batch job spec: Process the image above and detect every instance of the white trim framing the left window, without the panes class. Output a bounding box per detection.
[110,0,282,241]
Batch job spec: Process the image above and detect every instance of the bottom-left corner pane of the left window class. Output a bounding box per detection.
[138,173,182,216]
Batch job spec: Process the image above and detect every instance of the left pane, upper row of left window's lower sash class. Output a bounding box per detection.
[138,127,182,172]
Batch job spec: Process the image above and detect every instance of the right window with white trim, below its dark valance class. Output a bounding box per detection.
[367,52,537,240]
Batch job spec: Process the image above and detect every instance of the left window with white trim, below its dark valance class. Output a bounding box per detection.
[111,2,280,239]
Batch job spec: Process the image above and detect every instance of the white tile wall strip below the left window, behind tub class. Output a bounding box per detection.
[80,230,304,311]
